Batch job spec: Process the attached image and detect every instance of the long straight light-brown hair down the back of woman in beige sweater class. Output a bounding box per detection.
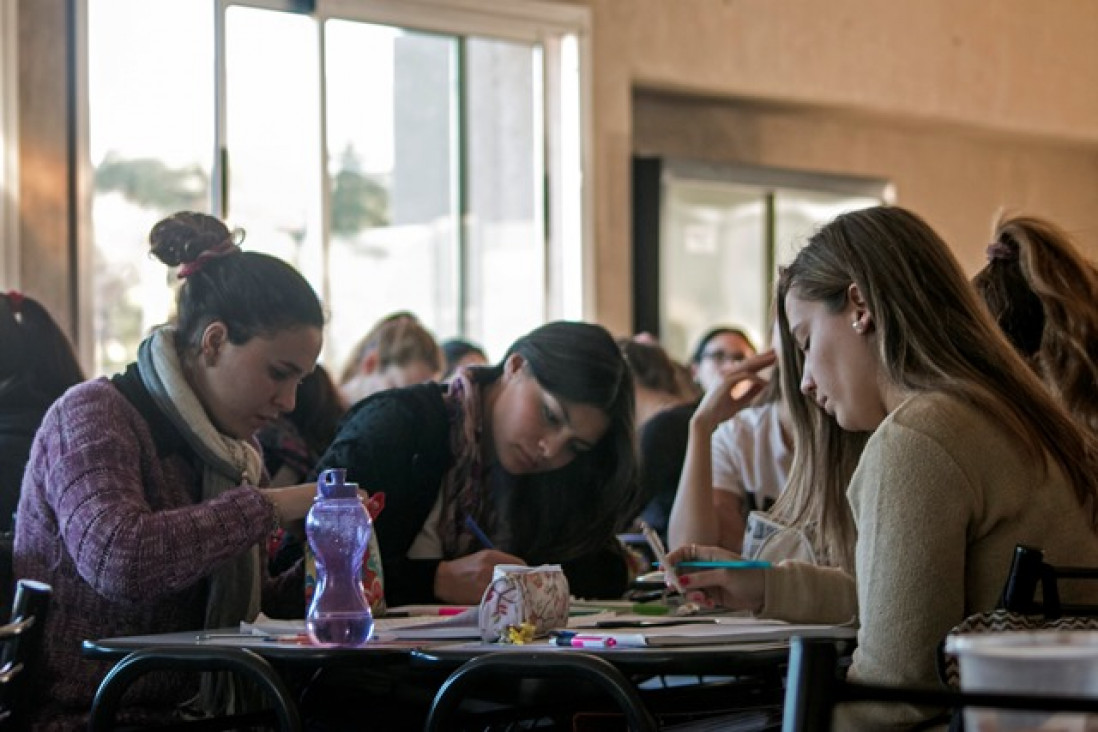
[778,206,1098,533]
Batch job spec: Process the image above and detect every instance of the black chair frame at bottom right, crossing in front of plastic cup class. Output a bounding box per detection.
[782,638,1098,732]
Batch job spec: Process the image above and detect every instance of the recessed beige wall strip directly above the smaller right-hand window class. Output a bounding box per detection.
[632,92,1098,273]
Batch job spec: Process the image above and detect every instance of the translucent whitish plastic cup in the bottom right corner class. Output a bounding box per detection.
[945,630,1098,732]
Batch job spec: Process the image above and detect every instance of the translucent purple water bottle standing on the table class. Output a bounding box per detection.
[305,468,373,646]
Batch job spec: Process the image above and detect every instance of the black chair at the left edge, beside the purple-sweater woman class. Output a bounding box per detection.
[0,579,54,729]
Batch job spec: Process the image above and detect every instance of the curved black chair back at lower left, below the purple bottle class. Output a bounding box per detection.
[88,645,302,732]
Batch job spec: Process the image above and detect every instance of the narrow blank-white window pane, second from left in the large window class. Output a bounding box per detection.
[225,5,324,293]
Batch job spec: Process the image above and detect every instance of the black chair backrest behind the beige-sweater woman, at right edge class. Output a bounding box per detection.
[999,544,1098,620]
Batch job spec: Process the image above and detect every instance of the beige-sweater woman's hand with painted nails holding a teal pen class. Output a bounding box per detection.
[666,544,770,612]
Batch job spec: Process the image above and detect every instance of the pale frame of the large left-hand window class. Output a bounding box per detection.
[77,0,595,375]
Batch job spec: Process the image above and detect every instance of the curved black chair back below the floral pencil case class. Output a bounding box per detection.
[425,651,659,732]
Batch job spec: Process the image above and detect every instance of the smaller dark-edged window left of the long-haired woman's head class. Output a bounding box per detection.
[634,157,894,360]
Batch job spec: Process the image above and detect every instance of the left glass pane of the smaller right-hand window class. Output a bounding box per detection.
[660,179,766,360]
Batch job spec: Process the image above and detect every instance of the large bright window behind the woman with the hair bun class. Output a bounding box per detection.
[86,0,589,373]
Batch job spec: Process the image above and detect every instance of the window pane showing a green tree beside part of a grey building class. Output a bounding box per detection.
[325,20,459,369]
